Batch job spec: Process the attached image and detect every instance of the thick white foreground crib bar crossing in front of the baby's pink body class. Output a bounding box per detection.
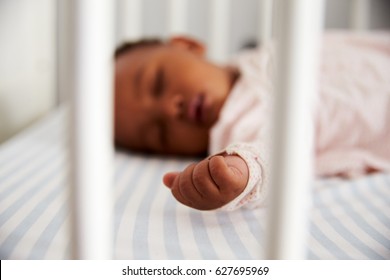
[266,0,323,259]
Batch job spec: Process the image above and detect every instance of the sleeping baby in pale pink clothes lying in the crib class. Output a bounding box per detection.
[114,32,390,210]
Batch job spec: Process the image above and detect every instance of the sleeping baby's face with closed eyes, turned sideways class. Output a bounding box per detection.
[115,37,238,155]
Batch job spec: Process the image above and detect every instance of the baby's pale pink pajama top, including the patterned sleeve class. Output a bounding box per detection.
[209,32,390,210]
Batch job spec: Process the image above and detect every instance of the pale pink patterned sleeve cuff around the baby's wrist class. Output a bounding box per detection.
[220,143,269,211]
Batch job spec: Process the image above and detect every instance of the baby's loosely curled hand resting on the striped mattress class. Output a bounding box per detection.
[163,155,249,210]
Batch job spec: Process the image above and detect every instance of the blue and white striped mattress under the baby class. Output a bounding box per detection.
[0,110,390,259]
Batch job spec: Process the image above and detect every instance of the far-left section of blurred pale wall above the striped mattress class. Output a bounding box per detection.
[0,0,56,142]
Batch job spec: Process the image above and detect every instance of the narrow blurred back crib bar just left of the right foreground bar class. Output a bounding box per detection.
[258,0,274,43]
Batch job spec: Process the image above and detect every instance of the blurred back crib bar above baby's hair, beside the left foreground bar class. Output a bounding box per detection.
[117,0,142,43]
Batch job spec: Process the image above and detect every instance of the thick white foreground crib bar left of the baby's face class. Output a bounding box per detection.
[69,0,114,259]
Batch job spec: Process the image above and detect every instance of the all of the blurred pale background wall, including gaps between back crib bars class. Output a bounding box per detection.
[0,0,390,143]
